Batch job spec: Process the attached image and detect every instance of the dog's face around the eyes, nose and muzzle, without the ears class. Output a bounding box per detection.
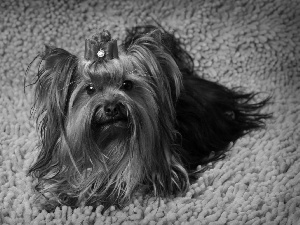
[75,58,162,150]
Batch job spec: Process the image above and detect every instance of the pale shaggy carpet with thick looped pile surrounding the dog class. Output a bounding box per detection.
[0,0,300,225]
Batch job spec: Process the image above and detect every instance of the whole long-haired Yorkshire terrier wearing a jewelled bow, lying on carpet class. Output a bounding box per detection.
[29,26,269,212]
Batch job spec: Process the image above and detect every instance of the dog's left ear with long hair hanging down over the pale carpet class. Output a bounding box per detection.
[35,45,78,117]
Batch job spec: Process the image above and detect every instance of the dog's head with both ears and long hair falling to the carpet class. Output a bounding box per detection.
[31,29,188,209]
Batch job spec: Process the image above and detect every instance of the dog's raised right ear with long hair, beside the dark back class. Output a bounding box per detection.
[125,29,182,104]
